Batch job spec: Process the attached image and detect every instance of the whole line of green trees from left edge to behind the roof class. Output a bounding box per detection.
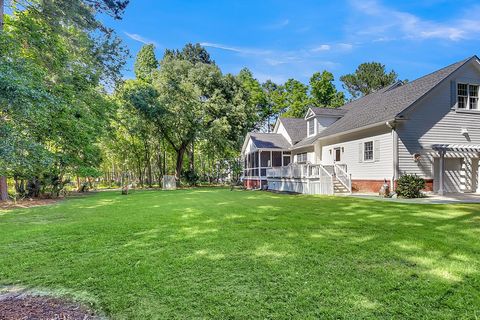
[0,0,397,200]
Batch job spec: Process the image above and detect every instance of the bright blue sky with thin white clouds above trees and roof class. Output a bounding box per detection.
[107,0,480,87]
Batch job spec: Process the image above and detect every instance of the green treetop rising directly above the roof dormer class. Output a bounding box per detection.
[310,70,345,108]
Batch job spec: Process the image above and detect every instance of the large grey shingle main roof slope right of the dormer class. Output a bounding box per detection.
[319,56,470,137]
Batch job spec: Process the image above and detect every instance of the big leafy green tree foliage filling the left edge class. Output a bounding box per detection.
[0,0,124,195]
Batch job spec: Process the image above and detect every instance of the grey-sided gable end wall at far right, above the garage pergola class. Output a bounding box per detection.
[396,63,480,188]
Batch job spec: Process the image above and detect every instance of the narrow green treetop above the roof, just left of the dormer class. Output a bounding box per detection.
[283,79,310,118]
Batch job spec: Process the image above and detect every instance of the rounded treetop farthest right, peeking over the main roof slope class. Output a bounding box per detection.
[340,62,398,98]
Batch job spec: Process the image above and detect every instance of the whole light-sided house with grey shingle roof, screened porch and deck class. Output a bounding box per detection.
[242,56,480,194]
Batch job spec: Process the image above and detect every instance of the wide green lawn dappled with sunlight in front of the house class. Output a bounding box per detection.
[0,189,480,319]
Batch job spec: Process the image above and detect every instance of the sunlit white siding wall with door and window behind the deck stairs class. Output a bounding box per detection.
[321,126,393,181]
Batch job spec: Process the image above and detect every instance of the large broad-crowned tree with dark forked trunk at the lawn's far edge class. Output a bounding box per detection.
[149,54,256,180]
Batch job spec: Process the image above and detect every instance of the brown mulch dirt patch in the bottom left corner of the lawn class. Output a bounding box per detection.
[0,291,101,320]
